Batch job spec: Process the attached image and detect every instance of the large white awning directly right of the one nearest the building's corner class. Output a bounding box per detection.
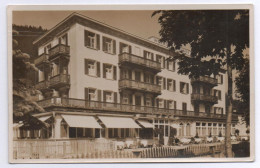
[98,116,141,128]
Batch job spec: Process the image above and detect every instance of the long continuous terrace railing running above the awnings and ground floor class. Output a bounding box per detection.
[38,98,240,120]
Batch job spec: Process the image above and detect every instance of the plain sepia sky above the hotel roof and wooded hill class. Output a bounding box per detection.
[13,10,160,38]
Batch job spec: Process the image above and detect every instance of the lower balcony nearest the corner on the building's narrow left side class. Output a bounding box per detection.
[49,74,70,88]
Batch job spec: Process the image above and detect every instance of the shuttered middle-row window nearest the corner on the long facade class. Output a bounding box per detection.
[85,59,100,77]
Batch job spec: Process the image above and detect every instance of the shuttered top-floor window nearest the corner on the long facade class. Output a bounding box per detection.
[85,30,100,50]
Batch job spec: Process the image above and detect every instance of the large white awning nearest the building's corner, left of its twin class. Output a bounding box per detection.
[61,115,102,128]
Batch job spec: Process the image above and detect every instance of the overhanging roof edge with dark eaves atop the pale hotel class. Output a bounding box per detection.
[33,12,175,54]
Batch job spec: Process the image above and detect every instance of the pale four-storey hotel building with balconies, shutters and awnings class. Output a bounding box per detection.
[13,13,237,144]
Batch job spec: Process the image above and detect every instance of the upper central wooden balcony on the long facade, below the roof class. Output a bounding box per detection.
[119,53,161,72]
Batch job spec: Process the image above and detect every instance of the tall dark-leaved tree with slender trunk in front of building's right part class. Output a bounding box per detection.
[152,10,249,157]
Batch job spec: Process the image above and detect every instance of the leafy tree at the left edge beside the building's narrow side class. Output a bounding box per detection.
[12,30,44,124]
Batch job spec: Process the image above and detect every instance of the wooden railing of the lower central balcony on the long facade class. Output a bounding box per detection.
[119,79,161,94]
